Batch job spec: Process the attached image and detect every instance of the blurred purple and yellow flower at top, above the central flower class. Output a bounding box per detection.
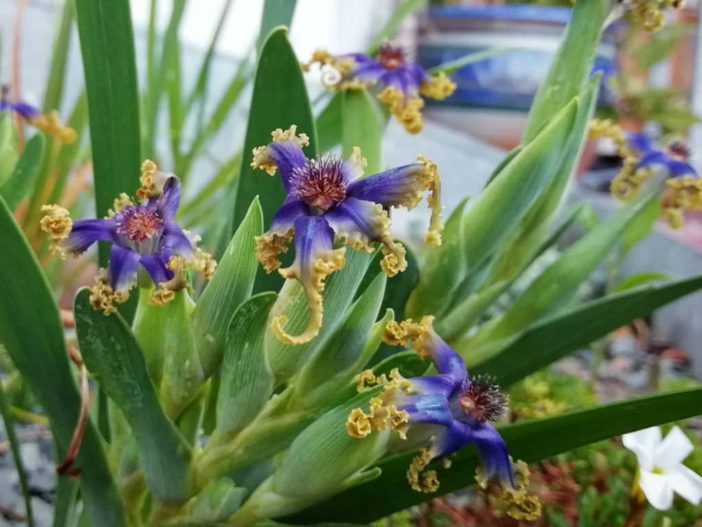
[303,44,456,134]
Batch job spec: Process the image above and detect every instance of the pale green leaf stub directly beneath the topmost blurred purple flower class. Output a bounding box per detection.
[341,90,387,174]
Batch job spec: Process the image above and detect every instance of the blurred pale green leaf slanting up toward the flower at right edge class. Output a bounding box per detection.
[466,189,658,348]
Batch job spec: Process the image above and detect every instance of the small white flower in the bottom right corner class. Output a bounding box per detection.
[622,426,702,510]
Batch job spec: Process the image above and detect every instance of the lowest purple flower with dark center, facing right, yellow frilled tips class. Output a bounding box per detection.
[346,316,514,492]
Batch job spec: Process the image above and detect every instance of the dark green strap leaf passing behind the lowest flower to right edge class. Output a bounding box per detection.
[283,388,702,525]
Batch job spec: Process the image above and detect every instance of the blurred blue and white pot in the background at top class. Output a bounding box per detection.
[418,4,616,112]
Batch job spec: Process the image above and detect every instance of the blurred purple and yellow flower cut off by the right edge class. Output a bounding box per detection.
[591,120,702,229]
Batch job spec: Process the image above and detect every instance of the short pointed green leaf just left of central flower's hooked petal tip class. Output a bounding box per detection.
[212,293,276,442]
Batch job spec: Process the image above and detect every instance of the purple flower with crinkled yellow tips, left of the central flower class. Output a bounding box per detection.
[41,160,215,314]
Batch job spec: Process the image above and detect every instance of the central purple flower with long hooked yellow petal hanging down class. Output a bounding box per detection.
[252,126,443,345]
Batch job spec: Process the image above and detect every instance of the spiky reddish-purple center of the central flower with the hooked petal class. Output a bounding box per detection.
[291,156,346,212]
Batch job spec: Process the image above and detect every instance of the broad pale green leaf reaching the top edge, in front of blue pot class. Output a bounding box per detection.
[522,0,611,143]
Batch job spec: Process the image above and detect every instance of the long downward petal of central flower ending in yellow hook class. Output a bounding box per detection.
[271,215,345,345]
